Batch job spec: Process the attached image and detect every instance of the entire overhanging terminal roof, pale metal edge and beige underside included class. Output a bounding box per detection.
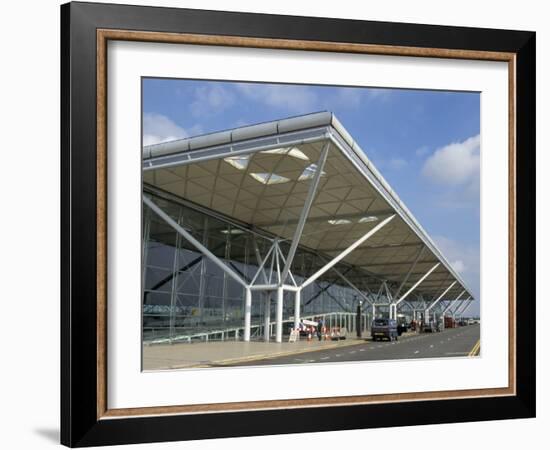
[143,112,474,298]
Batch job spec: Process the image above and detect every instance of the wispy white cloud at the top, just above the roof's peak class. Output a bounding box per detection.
[236,83,319,113]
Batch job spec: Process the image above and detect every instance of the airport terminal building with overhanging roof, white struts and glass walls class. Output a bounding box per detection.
[142,112,474,342]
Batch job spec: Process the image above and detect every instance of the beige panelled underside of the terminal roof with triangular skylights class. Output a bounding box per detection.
[143,113,471,300]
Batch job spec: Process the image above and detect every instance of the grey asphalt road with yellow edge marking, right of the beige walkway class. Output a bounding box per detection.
[226,324,479,366]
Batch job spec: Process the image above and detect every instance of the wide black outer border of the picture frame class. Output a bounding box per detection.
[61,3,536,447]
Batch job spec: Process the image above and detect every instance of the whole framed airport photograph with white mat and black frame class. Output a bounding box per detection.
[61,3,535,447]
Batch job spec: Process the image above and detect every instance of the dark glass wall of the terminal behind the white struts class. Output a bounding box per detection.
[142,190,380,341]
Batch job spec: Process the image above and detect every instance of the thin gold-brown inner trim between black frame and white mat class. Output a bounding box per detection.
[96,29,516,420]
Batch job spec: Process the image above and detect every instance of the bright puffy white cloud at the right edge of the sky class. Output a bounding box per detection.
[422,134,480,186]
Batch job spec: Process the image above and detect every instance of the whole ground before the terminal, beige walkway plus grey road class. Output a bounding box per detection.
[143,325,480,371]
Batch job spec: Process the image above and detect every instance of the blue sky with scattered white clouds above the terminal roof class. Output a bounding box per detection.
[143,79,480,313]
